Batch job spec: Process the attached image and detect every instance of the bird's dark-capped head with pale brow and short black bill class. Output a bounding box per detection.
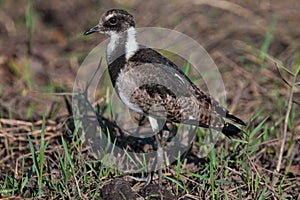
[84,9,135,36]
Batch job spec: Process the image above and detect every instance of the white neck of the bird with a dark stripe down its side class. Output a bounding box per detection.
[106,27,138,65]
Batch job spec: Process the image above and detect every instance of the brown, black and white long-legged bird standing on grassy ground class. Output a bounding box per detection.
[84,9,245,138]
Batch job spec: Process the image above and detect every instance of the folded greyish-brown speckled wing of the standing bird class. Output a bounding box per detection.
[116,62,221,127]
